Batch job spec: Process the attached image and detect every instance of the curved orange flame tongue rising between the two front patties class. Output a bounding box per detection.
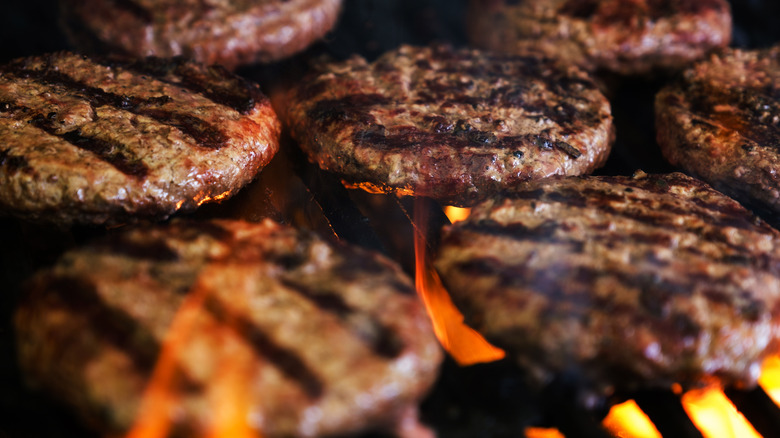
[414,200,506,365]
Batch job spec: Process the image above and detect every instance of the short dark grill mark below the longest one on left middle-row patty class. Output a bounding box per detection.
[29,115,149,180]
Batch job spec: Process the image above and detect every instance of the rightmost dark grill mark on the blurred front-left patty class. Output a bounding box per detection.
[282,280,403,359]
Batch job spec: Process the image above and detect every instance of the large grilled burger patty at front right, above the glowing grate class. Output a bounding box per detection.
[436,173,780,393]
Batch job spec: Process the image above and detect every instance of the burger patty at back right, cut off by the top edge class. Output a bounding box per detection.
[467,0,731,74]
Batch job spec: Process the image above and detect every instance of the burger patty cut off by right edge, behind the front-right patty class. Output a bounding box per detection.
[655,46,780,224]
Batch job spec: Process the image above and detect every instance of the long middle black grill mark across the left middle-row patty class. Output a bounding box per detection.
[5,68,228,149]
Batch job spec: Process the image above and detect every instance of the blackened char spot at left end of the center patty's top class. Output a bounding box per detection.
[307,94,391,126]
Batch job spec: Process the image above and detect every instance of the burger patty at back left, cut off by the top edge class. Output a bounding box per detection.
[61,0,341,69]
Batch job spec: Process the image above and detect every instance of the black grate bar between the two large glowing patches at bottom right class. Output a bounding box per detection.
[634,391,703,438]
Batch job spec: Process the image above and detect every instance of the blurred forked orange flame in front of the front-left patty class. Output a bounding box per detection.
[125,271,262,438]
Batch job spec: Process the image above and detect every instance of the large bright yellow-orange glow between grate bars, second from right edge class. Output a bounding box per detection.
[682,389,761,438]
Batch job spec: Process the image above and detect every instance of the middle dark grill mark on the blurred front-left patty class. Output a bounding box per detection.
[204,297,324,399]
